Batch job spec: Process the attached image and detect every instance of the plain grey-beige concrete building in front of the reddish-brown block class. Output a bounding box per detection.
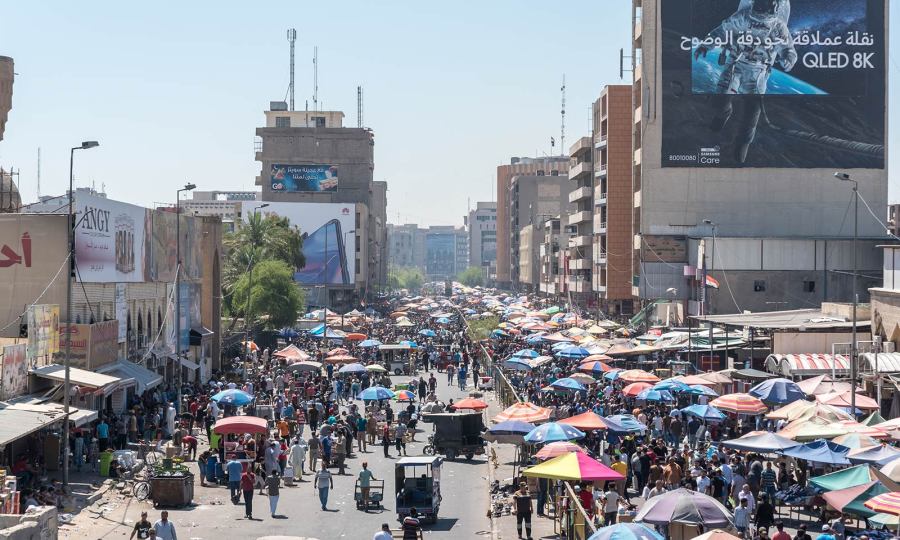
[506,172,569,287]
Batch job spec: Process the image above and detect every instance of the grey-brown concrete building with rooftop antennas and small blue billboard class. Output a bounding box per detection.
[256,102,387,306]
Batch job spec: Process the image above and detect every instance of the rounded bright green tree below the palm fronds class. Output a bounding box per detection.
[232,259,304,329]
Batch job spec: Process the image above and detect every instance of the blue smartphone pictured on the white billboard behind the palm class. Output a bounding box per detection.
[294,219,350,285]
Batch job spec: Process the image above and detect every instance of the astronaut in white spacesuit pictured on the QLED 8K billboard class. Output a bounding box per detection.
[694,0,797,163]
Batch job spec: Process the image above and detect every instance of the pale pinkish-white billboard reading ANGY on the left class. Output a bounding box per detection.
[75,193,147,283]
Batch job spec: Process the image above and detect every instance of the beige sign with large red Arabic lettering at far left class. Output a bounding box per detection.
[0,214,68,337]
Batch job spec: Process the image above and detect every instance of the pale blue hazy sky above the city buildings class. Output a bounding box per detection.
[0,0,900,225]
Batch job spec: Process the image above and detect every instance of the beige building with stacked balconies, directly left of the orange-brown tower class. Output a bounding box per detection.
[565,137,597,308]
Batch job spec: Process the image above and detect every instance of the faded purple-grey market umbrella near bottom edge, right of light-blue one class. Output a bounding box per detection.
[634,488,734,529]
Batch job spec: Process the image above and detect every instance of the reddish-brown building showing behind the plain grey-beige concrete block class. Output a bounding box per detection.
[497,156,569,287]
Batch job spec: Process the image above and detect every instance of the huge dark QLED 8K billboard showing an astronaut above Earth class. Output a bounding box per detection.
[660,0,887,169]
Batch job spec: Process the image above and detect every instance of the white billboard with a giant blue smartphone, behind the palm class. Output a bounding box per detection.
[242,201,356,285]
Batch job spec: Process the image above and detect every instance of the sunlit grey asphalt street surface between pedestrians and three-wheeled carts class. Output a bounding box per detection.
[60,373,490,540]
